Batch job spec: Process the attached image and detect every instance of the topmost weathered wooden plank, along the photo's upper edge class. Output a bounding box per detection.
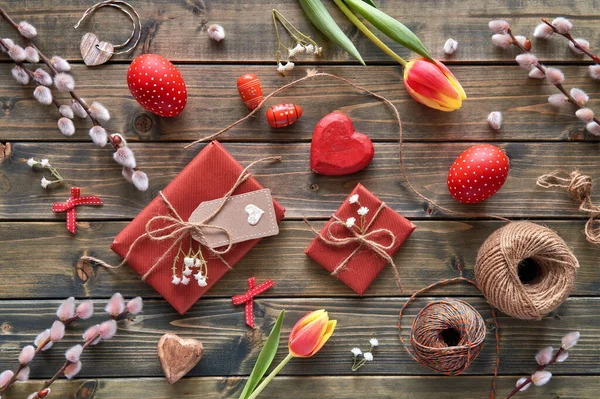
[0,0,600,63]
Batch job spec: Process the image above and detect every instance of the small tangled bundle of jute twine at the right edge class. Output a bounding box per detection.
[537,170,600,245]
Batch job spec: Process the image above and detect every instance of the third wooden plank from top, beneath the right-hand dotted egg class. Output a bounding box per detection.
[0,142,600,220]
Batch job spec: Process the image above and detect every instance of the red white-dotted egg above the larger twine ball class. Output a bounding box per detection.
[448,144,510,204]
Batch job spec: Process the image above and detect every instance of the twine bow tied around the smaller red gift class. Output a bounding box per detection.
[304,202,403,291]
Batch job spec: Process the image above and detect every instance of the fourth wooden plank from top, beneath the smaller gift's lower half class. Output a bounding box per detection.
[0,221,600,298]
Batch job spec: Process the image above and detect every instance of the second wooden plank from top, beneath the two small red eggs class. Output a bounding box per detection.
[0,64,600,142]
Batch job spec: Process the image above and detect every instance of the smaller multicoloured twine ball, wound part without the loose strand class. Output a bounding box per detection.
[410,299,486,375]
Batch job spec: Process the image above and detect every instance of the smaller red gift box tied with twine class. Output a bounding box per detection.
[305,184,416,295]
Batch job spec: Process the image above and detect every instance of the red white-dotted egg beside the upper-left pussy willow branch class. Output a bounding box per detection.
[127,54,187,116]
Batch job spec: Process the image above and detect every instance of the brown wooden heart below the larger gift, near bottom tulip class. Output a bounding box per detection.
[158,334,204,384]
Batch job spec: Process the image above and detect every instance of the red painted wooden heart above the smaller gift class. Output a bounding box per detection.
[310,112,375,176]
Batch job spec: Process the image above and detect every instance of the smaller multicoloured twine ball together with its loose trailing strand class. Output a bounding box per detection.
[398,277,500,399]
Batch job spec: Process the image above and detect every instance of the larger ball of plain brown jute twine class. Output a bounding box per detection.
[475,222,579,320]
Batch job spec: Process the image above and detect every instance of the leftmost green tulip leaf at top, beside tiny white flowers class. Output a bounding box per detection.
[298,0,368,65]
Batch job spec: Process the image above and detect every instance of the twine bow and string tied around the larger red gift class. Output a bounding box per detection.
[80,156,281,281]
